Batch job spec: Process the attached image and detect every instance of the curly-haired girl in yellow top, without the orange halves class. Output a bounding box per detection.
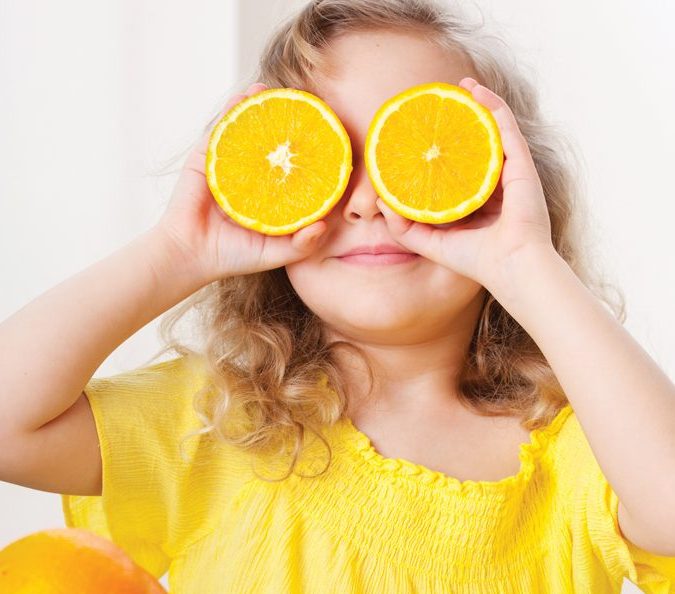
[0,0,675,594]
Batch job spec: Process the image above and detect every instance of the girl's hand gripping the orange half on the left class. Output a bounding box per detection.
[156,83,326,283]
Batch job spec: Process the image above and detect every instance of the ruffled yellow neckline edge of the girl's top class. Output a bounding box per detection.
[336,404,573,496]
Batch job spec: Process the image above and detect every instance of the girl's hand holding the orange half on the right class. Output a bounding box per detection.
[377,78,553,288]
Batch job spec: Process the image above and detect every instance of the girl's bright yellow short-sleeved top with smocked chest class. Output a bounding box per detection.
[61,357,675,594]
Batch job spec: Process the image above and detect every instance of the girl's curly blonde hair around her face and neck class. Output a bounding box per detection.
[145,0,626,480]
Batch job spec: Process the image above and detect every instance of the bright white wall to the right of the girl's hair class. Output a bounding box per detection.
[480,0,675,378]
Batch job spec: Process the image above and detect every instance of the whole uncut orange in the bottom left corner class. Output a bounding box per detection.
[0,528,166,594]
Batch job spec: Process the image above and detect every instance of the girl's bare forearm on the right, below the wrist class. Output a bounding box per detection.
[492,249,675,527]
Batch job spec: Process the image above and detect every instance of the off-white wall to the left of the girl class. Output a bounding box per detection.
[0,0,238,585]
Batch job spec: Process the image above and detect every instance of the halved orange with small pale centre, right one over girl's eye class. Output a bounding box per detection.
[364,82,504,224]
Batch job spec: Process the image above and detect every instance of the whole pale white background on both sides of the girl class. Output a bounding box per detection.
[0,0,675,592]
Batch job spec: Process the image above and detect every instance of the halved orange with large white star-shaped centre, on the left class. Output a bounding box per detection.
[206,88,352,235]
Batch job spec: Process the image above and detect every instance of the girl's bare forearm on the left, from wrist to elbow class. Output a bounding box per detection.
[0,227,205,434]
